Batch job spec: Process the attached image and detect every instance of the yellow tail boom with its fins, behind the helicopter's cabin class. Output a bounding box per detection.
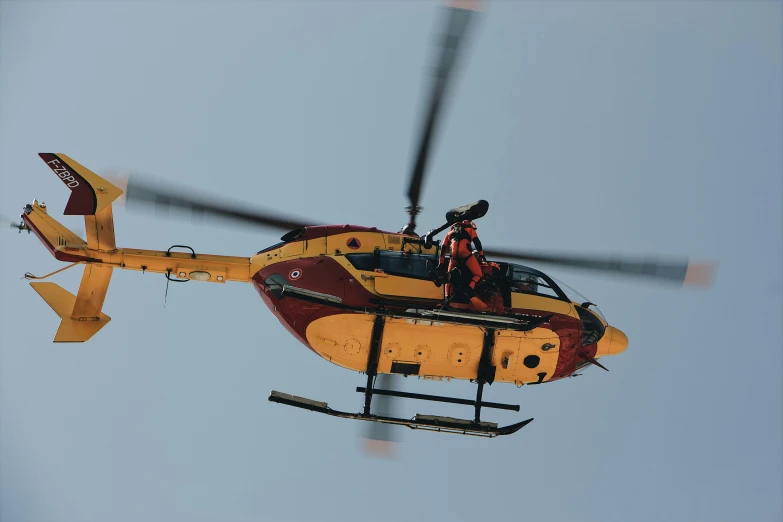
[21,153,253,342]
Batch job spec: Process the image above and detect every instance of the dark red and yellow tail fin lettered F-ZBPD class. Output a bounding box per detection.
[38,152,122,216]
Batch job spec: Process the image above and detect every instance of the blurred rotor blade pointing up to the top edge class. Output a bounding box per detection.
[408,0,479,233]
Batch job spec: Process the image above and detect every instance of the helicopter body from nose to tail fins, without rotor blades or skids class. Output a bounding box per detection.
[19,153,628,385]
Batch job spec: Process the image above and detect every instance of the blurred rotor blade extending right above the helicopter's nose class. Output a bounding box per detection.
[484,248,717,287]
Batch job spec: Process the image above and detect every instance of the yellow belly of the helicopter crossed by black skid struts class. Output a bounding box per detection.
[306,314,560,384]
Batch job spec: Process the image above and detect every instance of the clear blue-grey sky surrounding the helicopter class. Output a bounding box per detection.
[0,0,783,522]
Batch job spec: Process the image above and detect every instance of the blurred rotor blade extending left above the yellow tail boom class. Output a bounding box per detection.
[125,175,317,231]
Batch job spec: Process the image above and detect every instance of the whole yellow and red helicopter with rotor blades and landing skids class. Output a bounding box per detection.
[13,4,713,438]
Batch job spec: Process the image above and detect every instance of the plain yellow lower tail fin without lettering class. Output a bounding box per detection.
[30,264,112,343]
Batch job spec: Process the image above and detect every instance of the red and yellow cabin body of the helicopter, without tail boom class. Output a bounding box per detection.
[252,221,627,385]
